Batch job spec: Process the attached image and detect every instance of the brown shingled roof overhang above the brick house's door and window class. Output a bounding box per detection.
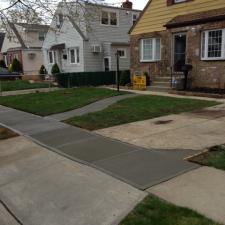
[165,8,225,28]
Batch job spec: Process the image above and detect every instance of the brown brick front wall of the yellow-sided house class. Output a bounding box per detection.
[131,21,225,88]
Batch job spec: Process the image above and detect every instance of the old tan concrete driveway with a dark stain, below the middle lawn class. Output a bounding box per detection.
[96,103,225,151]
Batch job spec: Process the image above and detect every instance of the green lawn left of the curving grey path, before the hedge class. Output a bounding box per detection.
[0,88,125,116]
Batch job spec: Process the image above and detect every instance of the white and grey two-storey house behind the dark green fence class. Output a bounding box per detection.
[43,0,140,72]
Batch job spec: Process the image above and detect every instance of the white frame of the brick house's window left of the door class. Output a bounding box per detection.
[140,37,161,62]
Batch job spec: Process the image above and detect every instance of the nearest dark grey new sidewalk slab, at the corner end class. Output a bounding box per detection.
[94,150,198,190]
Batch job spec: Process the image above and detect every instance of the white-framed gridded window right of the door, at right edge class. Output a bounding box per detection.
[201,29,225,60]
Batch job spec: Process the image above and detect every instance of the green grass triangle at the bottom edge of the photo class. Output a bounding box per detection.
[120,195,219,225]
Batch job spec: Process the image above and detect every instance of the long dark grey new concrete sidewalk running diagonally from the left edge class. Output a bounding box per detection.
[0,106,198,190]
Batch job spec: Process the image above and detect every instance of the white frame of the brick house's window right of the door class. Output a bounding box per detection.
[201,29,225,61]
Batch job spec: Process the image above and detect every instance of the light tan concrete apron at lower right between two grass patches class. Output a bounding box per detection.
[148,167,225,224]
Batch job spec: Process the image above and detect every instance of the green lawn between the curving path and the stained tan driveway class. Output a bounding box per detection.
[66,95,218,130]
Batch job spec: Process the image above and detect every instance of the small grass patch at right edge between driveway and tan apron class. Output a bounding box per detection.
[189,145,225,170]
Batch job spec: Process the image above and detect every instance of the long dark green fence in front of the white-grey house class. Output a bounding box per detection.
[55,71,130,88]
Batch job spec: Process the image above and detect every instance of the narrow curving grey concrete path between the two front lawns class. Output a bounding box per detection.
[48,94,138,121]
